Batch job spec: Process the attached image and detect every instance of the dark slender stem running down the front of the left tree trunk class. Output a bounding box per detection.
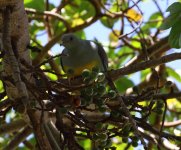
[3,7,51,150]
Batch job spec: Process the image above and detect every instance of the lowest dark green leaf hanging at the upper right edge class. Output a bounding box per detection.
[168,20,181,48]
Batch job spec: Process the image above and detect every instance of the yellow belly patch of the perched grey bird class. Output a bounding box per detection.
[63,61,99,77]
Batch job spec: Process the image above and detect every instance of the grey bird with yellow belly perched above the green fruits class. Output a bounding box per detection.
[60,33,108,77]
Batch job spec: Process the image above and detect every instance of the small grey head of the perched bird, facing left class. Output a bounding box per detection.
[61,33,80,49]
